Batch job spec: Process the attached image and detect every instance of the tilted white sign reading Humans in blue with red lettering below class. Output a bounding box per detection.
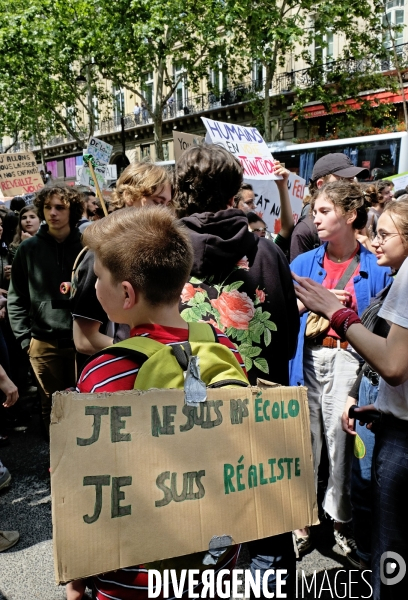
[201,117,280,181]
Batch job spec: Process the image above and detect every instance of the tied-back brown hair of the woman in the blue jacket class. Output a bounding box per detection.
[310,179,367,230]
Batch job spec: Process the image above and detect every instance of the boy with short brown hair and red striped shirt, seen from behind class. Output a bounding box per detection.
[67,207,242,600]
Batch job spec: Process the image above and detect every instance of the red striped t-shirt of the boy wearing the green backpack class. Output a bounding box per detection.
[77,325,245,600]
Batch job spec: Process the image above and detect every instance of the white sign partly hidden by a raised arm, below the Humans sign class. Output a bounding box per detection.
[252,173,306,234]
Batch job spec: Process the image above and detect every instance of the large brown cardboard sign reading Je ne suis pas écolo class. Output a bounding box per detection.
[50,386,317,582]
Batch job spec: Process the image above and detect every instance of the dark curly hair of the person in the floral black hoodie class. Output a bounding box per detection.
[174,144,243,215]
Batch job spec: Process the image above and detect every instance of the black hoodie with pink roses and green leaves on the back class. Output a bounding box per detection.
[181,209,299,385]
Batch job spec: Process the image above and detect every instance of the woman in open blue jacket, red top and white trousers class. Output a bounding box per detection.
[290,180,390,566]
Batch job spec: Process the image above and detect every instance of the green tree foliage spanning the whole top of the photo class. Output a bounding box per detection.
[0,0,402,158]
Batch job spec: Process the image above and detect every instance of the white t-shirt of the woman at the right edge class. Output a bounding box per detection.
[375,258,408,421]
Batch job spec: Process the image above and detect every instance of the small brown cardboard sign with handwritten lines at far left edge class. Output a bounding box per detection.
[0,152,44,197]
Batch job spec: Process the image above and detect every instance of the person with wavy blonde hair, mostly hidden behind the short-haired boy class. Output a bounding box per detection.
[71,163,172,355]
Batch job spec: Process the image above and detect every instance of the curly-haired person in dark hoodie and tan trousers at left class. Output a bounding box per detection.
[7,186,84,430]
